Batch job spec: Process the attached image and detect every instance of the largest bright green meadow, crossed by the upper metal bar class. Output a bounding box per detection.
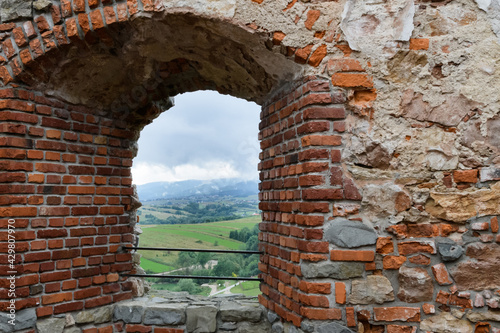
[139,216,261,273]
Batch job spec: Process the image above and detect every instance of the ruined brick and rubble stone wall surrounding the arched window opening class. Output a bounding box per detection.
[0,0,500,333]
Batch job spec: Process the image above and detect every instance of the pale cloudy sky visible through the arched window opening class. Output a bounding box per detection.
[132,91,260,185]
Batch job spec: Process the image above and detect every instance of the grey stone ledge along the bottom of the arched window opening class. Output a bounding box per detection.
[27,291,271,333]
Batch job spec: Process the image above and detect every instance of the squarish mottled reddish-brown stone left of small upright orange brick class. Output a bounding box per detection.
[398,266,434,303]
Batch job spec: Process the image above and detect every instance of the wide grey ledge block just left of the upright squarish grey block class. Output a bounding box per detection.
[144,303,188,325]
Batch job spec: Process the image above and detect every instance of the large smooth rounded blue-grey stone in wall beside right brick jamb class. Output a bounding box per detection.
[325,218,377,248]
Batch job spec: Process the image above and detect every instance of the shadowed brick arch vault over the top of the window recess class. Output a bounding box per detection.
[0,0,316,109]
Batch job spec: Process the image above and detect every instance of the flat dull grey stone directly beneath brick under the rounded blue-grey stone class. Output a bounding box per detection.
[300,261,365,280]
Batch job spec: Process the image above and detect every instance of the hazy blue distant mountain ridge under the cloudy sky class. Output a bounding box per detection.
[137,178,259,202]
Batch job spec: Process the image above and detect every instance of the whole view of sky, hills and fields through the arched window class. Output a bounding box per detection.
[132,91,260,296]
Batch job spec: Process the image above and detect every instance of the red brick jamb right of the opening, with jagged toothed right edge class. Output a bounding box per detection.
[259,77,360,326]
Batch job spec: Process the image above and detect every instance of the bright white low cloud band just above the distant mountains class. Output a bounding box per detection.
[132,161,244,185]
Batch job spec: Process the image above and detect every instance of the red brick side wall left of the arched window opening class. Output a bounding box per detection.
[0,86,135,317]
